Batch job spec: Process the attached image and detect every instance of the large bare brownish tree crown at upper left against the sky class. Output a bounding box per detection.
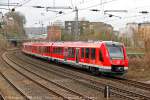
[4,12,26,38]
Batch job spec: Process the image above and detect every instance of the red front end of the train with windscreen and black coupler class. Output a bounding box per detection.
[101,41,128,76]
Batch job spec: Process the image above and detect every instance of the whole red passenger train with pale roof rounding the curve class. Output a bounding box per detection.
[22,41,128,75]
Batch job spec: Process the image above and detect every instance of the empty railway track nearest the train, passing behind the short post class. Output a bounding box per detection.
[11,51,150,100]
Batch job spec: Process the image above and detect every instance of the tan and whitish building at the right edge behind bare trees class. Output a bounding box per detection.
[121,22,150,48]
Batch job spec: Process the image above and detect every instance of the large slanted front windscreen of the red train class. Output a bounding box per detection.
[107,45,124,59]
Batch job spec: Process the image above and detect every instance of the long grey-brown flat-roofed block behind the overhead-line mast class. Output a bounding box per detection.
[65,21,113,34]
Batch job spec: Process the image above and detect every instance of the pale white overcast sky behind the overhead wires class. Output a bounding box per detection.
[0,0,150,29]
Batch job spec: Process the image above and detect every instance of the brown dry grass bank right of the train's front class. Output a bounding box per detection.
[127,53,150,81]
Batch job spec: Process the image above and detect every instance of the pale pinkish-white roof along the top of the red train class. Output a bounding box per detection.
[23,41,122,48]
